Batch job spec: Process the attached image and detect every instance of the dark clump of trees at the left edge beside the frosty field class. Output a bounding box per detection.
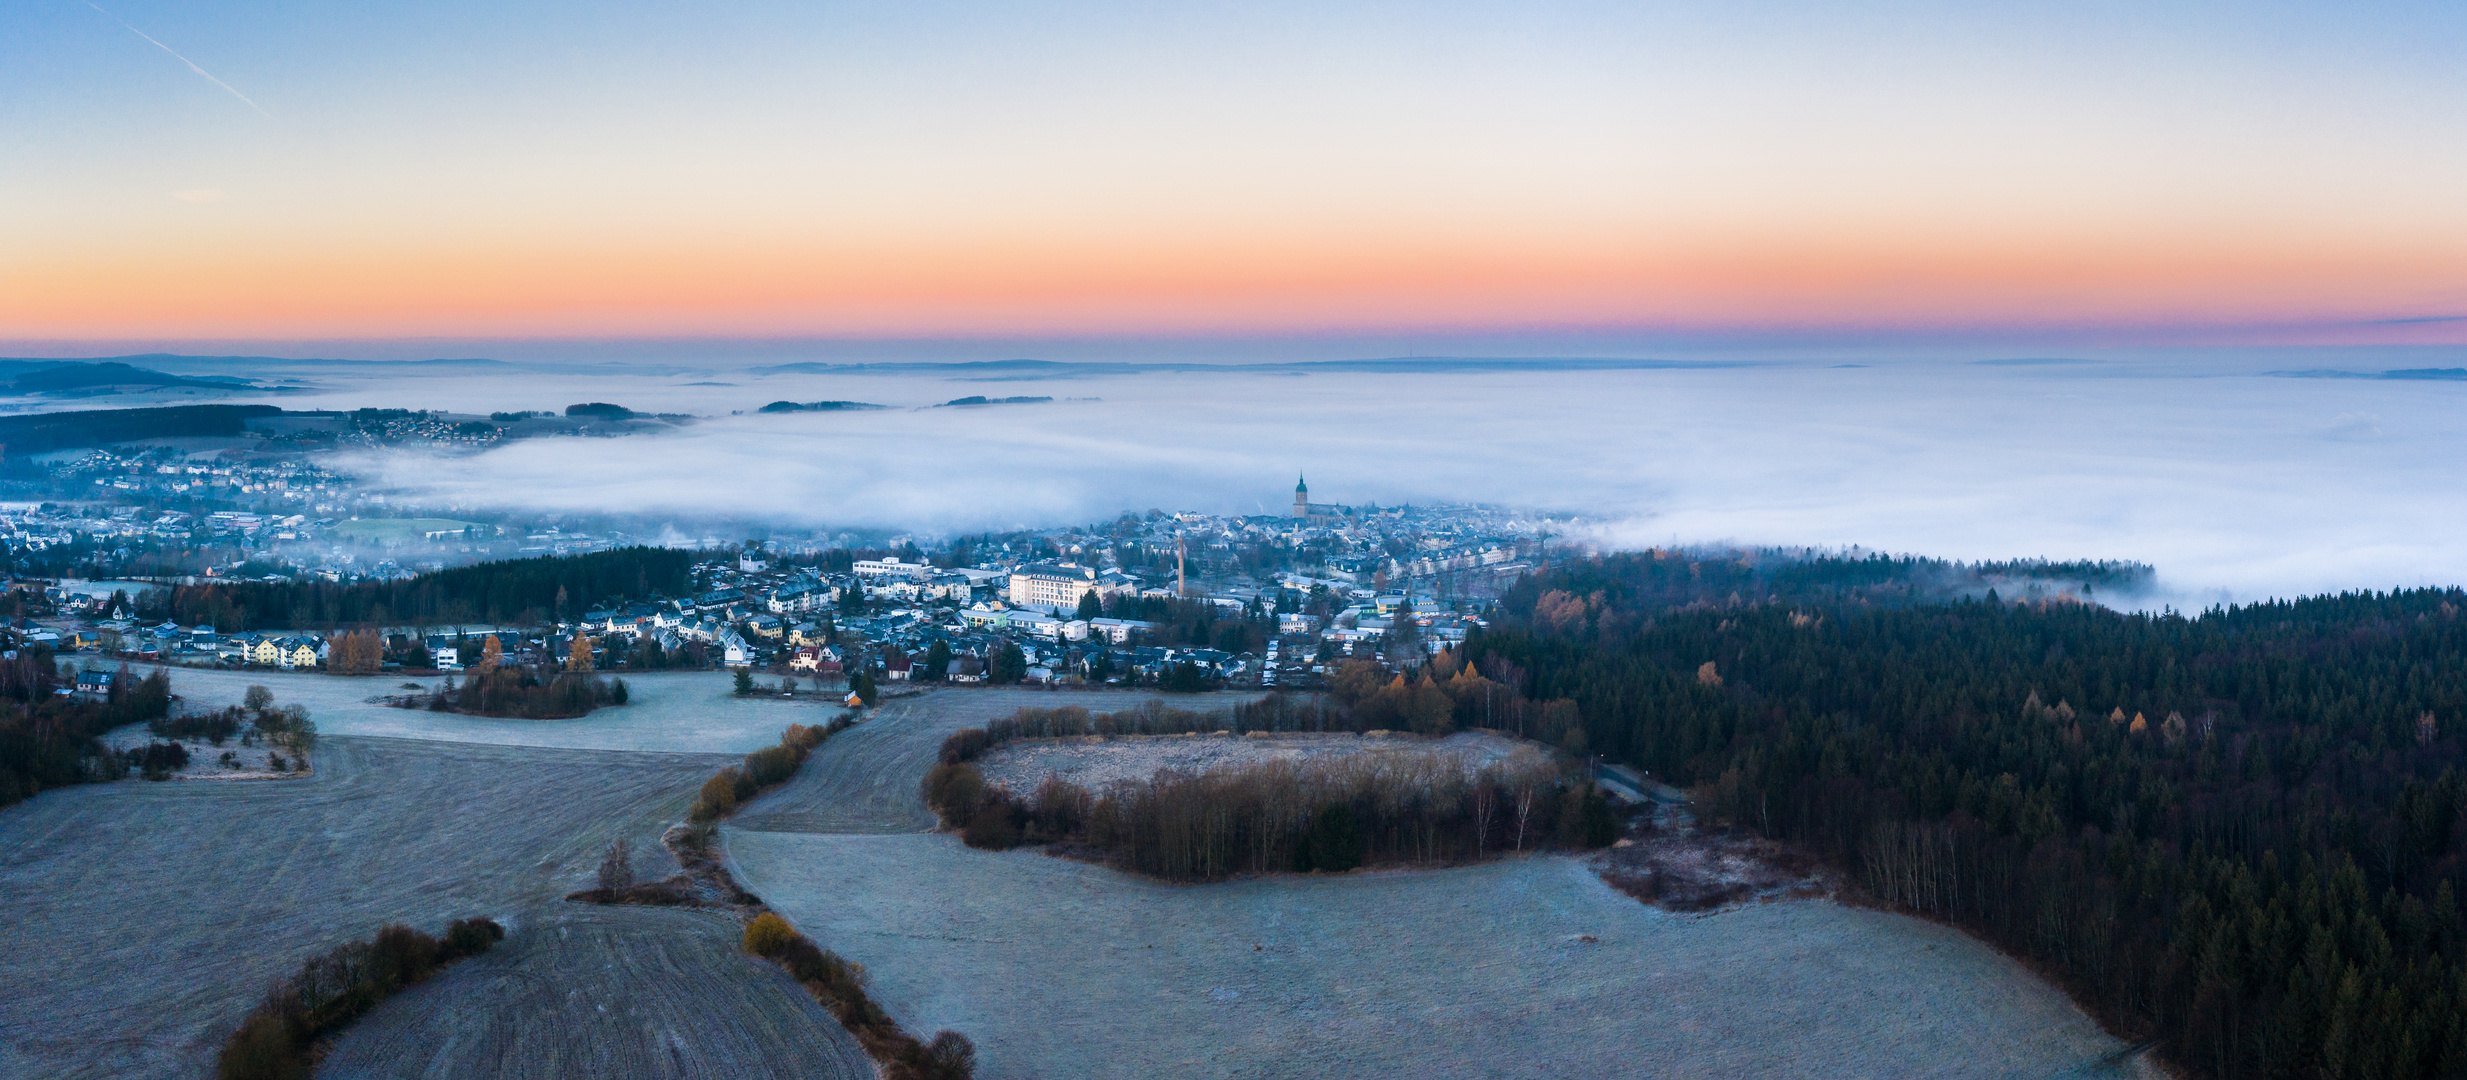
[0,646,170,806]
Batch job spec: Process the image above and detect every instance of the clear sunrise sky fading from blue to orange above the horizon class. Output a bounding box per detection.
[14,0,2467,345]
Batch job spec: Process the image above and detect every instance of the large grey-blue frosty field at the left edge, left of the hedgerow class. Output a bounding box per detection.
[0,729,868,1078]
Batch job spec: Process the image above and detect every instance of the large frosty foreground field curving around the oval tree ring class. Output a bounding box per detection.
[723,693,2151,1080]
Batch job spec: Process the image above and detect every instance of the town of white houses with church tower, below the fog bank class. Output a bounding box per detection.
[0,483,1564,690]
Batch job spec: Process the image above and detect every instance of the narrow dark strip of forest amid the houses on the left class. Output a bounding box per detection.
[170,547,696,634]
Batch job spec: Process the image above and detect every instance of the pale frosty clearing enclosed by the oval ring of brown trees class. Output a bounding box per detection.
[977,732,1532,794]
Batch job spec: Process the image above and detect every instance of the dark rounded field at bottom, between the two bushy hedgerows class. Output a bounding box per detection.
[318,905,873,1080]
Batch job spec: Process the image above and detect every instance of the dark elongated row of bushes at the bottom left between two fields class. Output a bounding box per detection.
[215,917,506,1080]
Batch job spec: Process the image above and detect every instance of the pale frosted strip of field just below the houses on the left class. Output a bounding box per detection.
[170,668,839,755]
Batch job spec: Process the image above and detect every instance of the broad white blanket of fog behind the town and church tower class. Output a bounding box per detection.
[280,362,2467,604]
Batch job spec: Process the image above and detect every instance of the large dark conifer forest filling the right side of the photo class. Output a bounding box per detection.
[1468,555,2467,1078]
